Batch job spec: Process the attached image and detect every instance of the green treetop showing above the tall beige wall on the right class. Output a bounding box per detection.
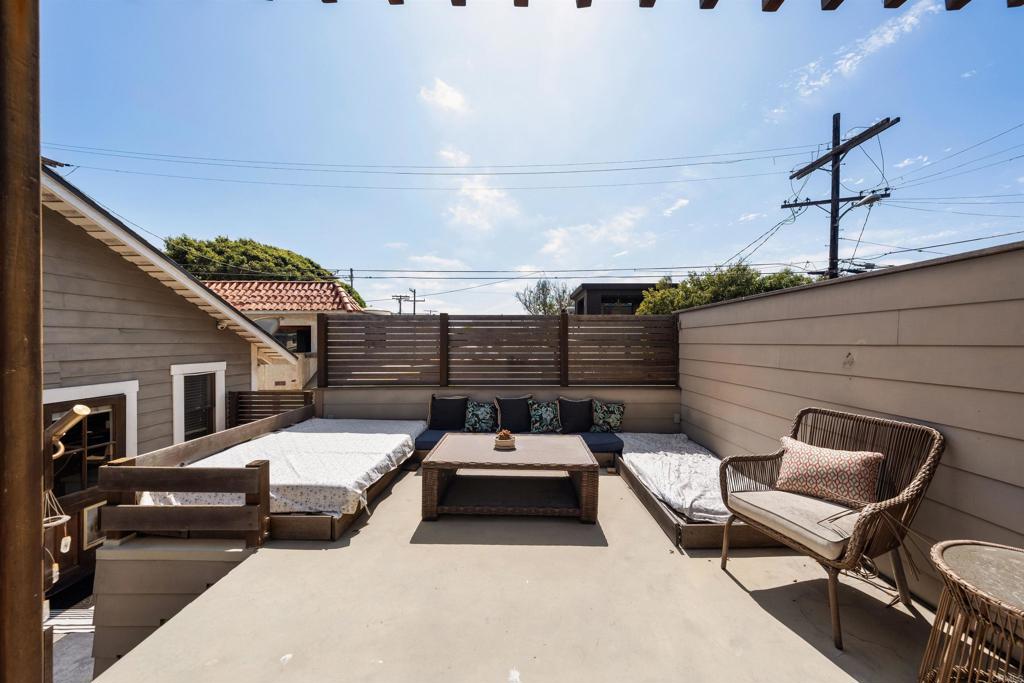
[637,263,814,315]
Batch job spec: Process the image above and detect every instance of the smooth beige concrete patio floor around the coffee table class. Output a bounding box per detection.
[92,473,931,683]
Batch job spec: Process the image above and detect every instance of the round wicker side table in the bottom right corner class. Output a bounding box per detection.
[918,541,1024,683]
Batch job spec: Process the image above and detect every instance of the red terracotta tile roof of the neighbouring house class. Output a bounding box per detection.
[203,280,362,313]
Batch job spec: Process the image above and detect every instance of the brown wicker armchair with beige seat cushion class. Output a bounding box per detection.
[720,408,944,649]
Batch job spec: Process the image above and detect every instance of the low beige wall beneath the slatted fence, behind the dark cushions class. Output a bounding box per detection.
[316,386,679,433]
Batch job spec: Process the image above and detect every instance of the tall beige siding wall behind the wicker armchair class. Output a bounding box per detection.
[679,245,1024,603]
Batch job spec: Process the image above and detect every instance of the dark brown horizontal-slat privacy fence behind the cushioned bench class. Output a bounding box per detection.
[317,313,679,387]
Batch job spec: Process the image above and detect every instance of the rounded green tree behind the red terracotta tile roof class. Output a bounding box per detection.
[164,234,367,306]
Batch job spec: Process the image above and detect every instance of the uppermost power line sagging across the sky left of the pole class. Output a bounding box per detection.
[43,142,820,170]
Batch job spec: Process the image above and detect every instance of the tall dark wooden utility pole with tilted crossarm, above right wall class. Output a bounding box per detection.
[782,113,899,279]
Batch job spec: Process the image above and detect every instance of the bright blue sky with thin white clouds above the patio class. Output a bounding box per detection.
[41,0,1024,313]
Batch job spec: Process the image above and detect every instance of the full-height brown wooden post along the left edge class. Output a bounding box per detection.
[0,0,43,683]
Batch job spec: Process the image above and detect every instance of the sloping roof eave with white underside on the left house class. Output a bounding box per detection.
[41,167,296,364]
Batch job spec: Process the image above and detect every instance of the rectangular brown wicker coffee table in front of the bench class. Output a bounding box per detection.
[423,433,598,523]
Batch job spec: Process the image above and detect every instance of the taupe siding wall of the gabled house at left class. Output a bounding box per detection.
[43,208,251,454]
